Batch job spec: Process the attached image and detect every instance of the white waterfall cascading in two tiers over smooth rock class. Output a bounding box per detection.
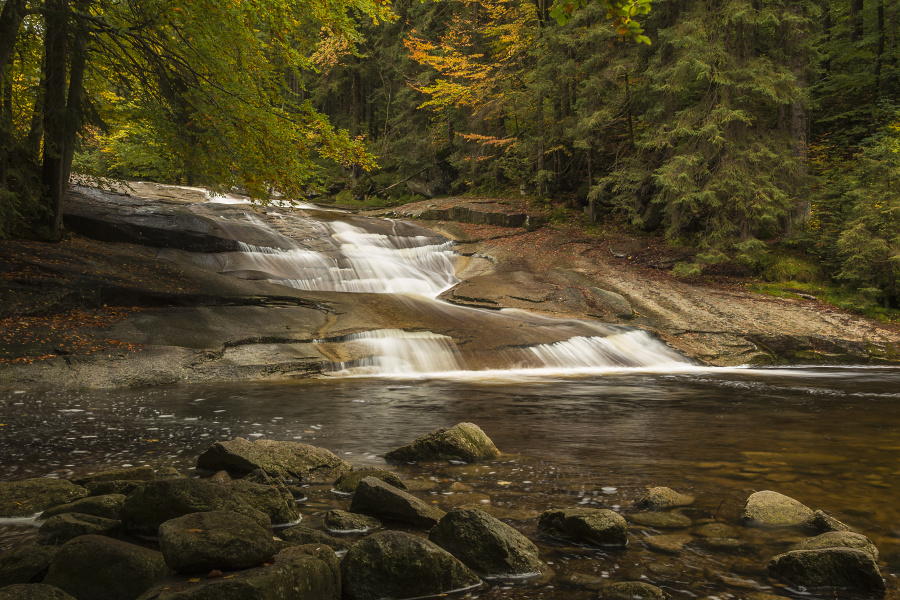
[207,204,692,377]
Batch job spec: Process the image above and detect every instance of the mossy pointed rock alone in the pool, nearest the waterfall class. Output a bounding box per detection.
[384,423,500,463]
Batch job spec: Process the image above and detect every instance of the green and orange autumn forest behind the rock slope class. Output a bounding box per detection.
[0,0,900,315]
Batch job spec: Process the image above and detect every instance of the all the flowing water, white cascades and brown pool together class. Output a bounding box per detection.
[0,199,900,599]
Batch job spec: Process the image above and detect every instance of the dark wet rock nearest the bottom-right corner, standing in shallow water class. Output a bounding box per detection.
[766,548,885,593]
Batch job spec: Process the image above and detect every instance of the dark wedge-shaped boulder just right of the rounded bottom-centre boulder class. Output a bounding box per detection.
[428,508,550,579]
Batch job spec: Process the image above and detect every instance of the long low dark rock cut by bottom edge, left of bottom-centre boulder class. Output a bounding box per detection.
[139,554,340,600]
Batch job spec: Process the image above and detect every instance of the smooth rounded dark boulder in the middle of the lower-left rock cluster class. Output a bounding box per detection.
[159,511,275,573]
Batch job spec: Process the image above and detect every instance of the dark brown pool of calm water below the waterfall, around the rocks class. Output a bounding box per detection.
[0,368,900,598]
